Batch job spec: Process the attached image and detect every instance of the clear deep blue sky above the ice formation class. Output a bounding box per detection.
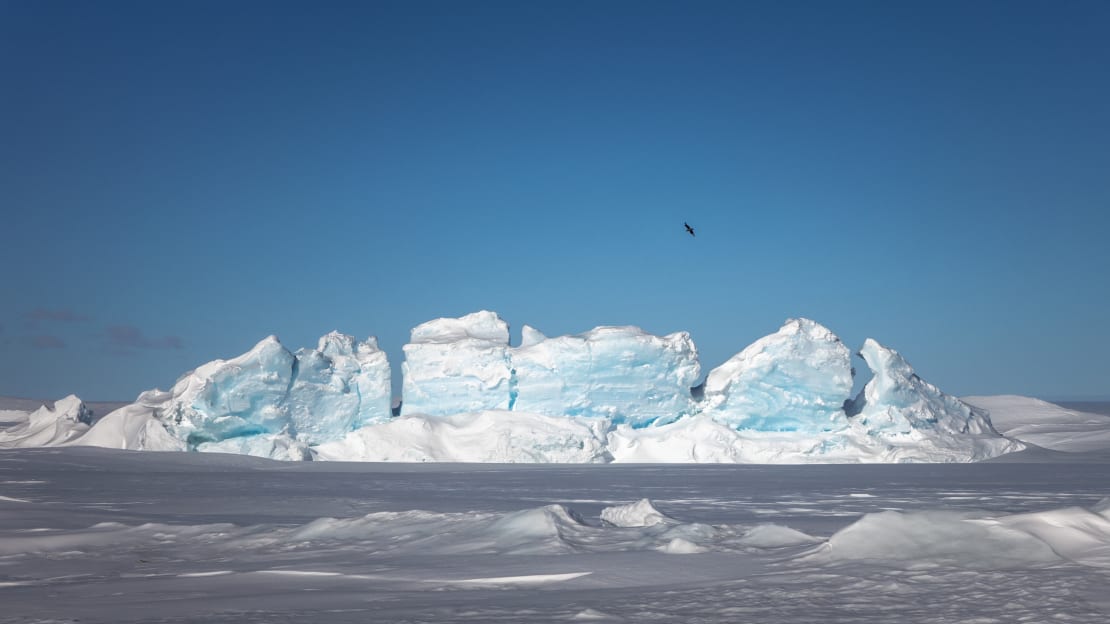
[0,0,1110,400]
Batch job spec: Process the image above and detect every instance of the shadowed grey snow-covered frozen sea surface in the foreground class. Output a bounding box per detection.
[0,447,1110,624]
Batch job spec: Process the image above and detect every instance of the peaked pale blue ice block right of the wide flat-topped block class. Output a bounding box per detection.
[704,319,852,433]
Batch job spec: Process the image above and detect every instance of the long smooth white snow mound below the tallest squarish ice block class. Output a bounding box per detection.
[315,410,609,463]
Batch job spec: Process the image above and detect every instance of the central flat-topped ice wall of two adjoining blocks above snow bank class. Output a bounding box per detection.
[402,311,700,424]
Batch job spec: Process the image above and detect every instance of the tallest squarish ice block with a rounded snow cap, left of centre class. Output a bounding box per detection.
[401,311,512,416]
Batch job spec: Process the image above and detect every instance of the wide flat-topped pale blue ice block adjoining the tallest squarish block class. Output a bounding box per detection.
[511,326,702,425]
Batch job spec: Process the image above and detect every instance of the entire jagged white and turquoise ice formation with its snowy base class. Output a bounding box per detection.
[0,311,1022,463]
